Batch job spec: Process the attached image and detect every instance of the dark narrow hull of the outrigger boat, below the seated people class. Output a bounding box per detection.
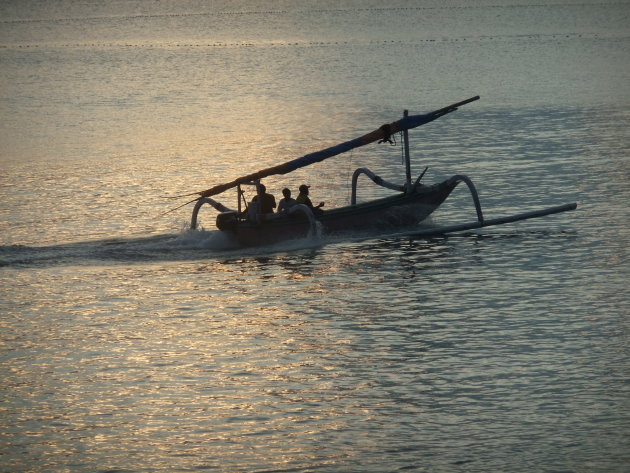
[225,178,459,246]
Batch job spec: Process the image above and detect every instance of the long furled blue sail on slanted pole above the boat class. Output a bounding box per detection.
[195,95,479,197]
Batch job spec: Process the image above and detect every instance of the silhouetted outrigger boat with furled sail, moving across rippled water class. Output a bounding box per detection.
[172,96,577,246]
